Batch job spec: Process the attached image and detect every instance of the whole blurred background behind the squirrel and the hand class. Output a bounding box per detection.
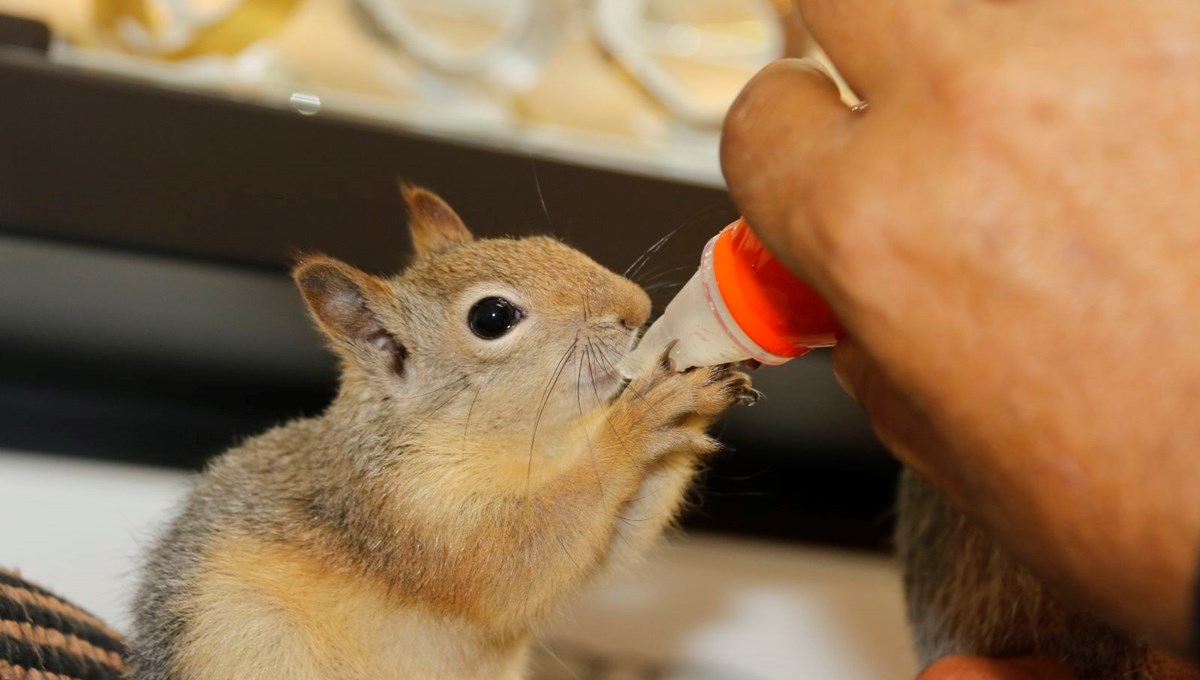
[0,0,913,679]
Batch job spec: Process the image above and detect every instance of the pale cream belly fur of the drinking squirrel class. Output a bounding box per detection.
[175,538,524,680]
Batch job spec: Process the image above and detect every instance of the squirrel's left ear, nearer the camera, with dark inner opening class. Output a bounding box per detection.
[292,255,408,373]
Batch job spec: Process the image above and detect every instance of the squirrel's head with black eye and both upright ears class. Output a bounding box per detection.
[293,187,650,458]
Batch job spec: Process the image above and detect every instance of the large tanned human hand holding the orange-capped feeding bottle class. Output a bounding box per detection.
[721,0,1200,652]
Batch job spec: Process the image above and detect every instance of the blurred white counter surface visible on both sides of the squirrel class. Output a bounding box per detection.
[0,451,916,680]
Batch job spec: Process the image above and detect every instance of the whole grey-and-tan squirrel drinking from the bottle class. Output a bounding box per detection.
[131,188,756,680]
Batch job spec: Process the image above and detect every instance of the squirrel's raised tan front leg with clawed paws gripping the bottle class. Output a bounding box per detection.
[458,367,756,626]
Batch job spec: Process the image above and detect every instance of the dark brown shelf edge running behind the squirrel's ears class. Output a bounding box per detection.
[0,52,733,278]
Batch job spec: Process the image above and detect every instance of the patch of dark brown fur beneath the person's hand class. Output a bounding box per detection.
[896,470,1200,680]
